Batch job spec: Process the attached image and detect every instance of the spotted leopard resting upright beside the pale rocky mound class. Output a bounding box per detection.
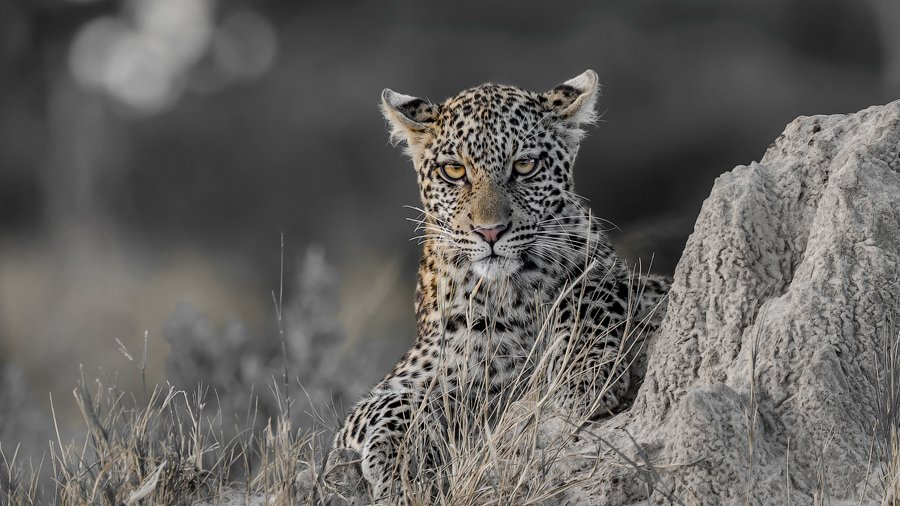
[329,70,671,503]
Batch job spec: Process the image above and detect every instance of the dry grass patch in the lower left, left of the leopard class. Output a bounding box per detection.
[0,370,330,505]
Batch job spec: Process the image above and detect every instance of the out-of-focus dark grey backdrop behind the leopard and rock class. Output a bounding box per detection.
[0,0,900,454]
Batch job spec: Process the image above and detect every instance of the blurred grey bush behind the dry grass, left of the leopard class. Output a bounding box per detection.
[163,247,364,440]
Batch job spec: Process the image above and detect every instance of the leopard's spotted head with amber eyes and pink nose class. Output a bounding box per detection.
[382,71,598,279]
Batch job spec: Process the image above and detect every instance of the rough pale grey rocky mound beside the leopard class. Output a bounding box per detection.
[559,101,900,505]
